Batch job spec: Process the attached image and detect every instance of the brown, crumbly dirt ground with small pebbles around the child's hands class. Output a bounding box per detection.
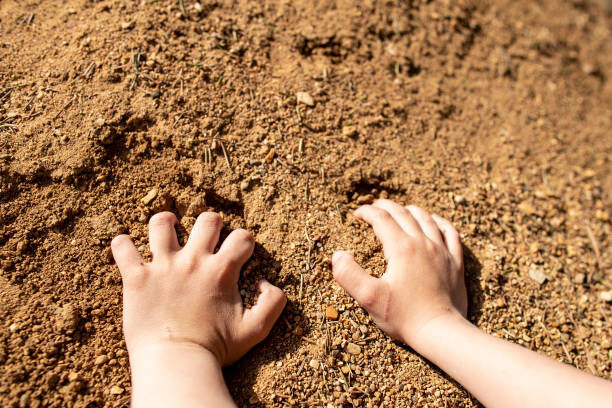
[0,0,612,407]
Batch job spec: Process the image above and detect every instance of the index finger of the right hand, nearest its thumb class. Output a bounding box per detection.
[354,205,407,259]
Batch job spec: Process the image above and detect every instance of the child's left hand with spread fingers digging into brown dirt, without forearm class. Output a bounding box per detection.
[111,212,286,366]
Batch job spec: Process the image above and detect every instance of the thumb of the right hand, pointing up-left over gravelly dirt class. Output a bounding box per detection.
[332,251,382,313]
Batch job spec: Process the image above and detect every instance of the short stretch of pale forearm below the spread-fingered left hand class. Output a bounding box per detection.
[130,344,236,408]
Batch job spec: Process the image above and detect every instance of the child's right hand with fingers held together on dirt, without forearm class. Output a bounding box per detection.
[332,200,467,348]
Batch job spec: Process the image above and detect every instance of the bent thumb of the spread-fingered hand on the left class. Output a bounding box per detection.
[242,279,287,345]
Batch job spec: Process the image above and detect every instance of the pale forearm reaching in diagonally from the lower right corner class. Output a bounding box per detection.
[414,316,612,407]
